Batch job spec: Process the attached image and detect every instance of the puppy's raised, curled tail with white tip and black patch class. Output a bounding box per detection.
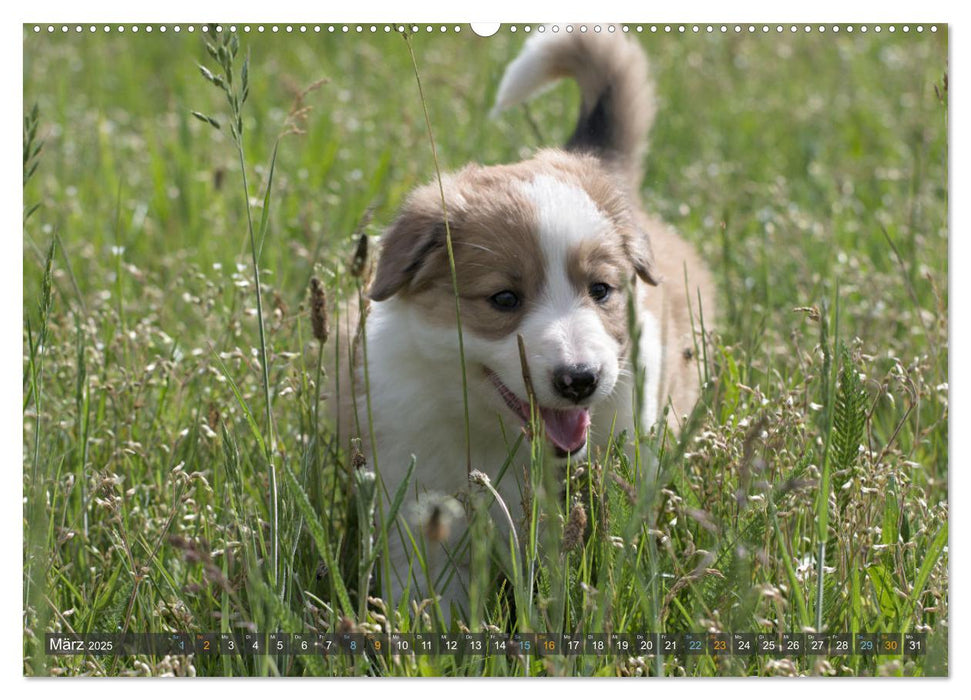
[492,27,656,189]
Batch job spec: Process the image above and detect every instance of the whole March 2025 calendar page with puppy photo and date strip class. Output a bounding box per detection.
[21,11,950,682]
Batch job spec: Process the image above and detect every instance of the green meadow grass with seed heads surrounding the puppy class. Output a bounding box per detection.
[23,28,948,676]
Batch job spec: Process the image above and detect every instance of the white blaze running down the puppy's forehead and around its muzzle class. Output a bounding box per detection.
[522,175,619,405]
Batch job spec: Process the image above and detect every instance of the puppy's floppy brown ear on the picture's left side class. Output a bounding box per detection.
[368,196,445,301]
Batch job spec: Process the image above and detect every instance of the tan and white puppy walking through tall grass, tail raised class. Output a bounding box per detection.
[340,32,715,616]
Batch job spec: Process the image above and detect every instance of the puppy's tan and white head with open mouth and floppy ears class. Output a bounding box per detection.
[370,151,656,456]
